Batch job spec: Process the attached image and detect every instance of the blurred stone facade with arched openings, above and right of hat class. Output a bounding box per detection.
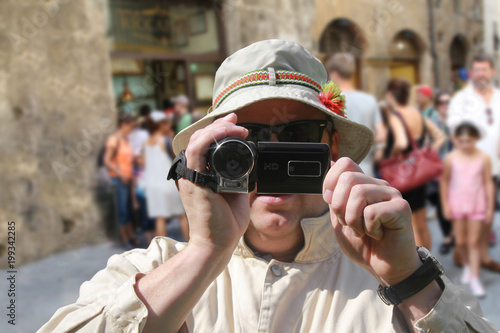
[225,0,484,97]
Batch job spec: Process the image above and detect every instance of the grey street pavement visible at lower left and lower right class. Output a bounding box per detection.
[0,214,500,333]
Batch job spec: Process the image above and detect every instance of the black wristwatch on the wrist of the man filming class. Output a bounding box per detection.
[377,248,443,305]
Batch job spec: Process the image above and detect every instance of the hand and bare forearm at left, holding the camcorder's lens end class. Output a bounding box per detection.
[135,114,250,333]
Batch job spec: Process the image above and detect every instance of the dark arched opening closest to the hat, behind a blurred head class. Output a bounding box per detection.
[319,18,366,88]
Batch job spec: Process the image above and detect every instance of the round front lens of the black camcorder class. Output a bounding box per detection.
[212,141,254,179]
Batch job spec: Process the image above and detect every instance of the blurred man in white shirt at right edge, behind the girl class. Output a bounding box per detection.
[448,54,500,272]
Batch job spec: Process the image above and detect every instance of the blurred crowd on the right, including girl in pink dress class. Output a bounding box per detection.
[326,53,500,297]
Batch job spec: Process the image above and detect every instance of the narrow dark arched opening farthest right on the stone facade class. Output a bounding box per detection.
[450,34,468,91]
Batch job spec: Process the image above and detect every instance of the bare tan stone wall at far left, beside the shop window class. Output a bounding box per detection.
[0,0,115,267]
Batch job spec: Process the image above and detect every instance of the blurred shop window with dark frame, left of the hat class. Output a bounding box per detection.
[107,0,226,113]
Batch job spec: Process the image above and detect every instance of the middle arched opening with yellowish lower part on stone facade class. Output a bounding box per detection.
[389,30,423,85]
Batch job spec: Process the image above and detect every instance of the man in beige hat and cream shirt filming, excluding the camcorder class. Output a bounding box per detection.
[40,40,496,332]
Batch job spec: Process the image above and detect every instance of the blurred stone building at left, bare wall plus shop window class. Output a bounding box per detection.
[0,0,227,267]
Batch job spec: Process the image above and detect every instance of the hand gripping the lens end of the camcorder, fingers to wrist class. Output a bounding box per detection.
[179,113,250,253]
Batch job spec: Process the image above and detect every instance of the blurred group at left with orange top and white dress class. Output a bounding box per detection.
[99,95,197,249]
